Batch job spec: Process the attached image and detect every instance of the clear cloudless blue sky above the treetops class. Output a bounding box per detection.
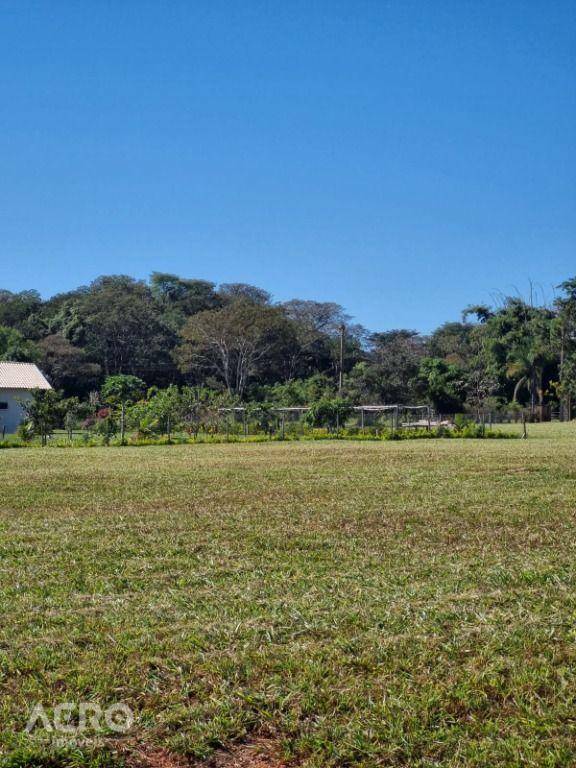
[0,0,576,331]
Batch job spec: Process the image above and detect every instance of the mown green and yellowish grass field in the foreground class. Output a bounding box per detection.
[0,425,576,768]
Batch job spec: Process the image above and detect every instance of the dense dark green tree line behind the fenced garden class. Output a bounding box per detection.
[0,272,576,418]
